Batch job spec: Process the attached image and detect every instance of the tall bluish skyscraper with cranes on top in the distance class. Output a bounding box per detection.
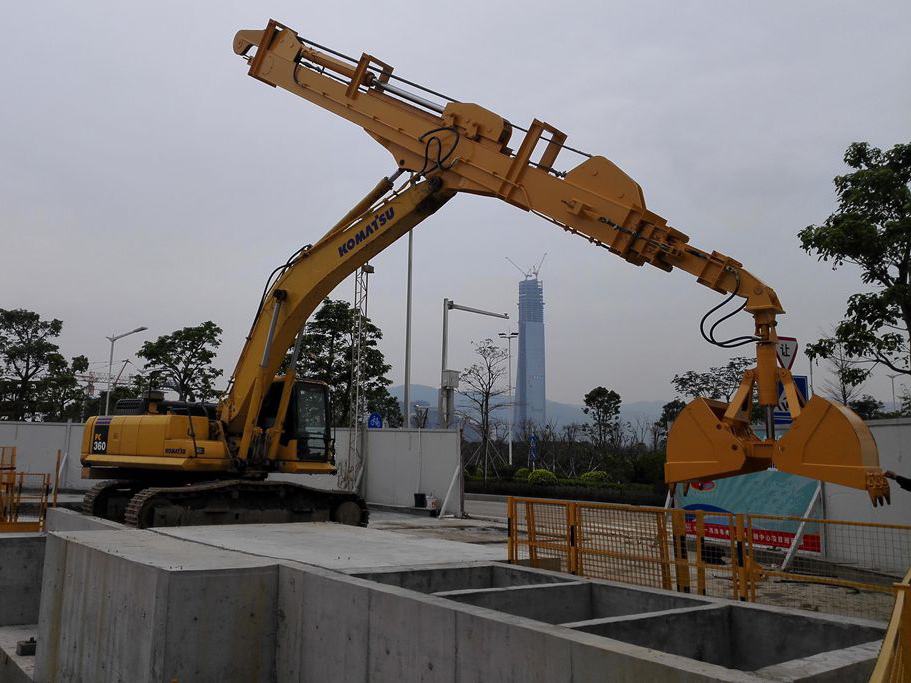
[513,270,547,431]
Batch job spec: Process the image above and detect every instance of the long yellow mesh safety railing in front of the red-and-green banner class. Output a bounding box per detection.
[508,498,911,621]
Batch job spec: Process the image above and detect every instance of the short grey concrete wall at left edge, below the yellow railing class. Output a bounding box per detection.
[0,534,44,626]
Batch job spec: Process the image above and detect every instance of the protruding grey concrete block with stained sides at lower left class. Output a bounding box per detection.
[35,530,278,683]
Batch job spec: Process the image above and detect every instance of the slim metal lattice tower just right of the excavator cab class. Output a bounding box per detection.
[338,263,373,491]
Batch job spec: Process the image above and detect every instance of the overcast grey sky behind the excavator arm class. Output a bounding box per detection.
[0,0,911,403]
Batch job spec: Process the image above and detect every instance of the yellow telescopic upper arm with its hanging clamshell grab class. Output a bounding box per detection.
[232,20,889,504]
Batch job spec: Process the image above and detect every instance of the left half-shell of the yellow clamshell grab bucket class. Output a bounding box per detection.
[664,398,770,483]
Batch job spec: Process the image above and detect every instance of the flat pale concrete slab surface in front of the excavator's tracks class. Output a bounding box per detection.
[152,522,506,570]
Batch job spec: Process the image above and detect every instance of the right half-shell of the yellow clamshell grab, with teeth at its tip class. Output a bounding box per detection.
[773,396,889,505]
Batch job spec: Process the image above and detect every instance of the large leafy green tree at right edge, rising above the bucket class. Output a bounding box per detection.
[798,142,911,384]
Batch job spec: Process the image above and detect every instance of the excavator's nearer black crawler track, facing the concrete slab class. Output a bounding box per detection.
[124,479,369,529]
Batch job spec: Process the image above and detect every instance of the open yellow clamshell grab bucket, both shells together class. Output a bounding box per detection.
[664,396,889,505]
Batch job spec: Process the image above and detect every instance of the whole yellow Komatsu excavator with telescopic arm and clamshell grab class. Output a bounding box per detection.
[82,20,889,527]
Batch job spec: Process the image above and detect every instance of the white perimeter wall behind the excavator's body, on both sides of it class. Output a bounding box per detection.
[0,422,459,512]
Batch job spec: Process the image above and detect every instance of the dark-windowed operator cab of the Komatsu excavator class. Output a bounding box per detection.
[258,378,334,462]
